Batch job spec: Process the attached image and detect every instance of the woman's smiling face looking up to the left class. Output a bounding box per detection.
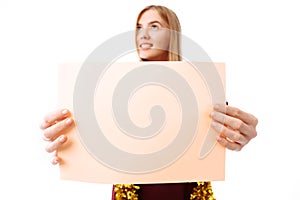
[136,9,170,61]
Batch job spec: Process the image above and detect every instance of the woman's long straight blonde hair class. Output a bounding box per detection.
[136,5,182,61]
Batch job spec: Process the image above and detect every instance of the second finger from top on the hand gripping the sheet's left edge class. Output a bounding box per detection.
[44,118,73,140]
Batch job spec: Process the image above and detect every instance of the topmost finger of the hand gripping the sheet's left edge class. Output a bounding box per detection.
[40,109,70,130]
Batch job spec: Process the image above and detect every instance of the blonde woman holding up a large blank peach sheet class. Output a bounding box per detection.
[41,6,258,200]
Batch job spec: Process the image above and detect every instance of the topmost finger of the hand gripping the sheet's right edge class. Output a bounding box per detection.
[214,104,258,126]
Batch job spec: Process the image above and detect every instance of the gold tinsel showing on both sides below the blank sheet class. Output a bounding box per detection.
[114,182,216,200]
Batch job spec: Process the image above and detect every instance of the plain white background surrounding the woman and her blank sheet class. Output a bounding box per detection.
[0,0,300,200]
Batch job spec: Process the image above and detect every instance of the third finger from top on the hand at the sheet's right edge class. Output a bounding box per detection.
[212,122,249,145]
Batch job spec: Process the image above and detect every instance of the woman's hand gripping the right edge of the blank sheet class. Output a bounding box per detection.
[211,105,258,151]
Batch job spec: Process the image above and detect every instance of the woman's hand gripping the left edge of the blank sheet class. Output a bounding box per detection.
[40,109,74,165]
